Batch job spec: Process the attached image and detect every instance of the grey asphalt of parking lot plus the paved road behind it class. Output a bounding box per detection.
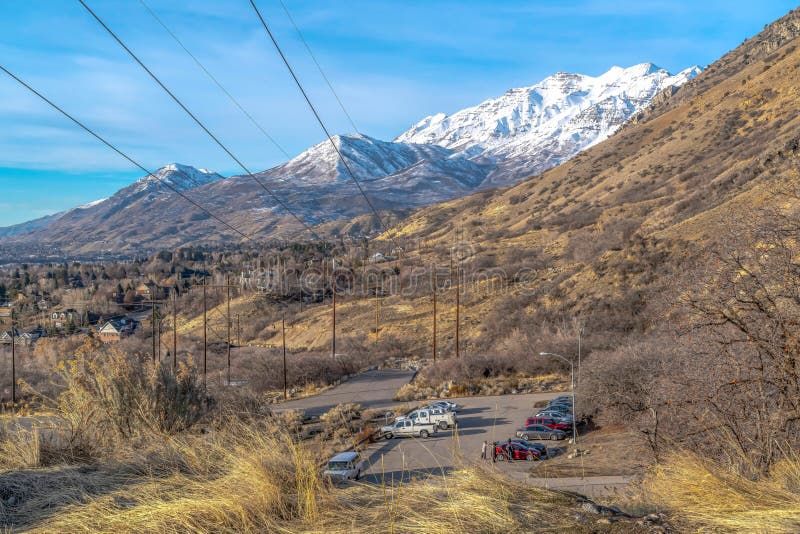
[278,370,631,496]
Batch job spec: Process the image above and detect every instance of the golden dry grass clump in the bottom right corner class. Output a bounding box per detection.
[640,453,800,532]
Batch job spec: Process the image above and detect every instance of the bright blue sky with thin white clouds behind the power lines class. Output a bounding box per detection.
[0,0,795,225]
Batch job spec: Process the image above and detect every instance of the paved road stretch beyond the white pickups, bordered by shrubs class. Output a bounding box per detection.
[274,369,414,415]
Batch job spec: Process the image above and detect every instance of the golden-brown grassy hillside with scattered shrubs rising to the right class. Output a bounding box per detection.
[241,7,800,355]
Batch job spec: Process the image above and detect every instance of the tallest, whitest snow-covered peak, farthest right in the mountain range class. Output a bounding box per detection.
[395,63,700,186]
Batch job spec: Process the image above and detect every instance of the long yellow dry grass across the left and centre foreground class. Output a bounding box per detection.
[0,423,636,533]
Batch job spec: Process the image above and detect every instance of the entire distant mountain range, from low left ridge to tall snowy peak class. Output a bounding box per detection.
[0,63,698,254]
